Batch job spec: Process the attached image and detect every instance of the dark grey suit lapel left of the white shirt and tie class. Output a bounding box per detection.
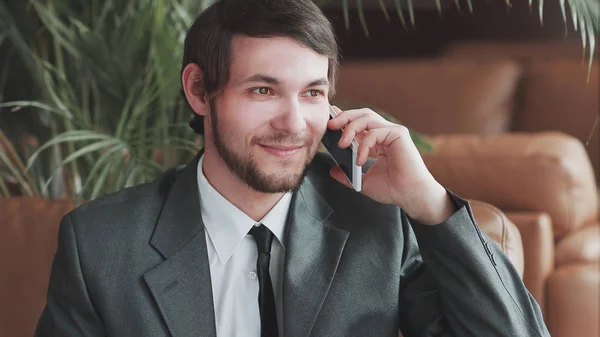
[144,152,216,337]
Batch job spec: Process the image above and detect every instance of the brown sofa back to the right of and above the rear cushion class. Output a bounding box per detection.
[443,38,600,181]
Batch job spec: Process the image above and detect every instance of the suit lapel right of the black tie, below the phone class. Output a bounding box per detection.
[282,177,349,337]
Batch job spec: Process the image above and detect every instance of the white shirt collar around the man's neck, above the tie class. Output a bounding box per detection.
[197,155,292,263]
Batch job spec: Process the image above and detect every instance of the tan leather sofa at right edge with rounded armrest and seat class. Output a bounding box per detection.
[425,132,600,337]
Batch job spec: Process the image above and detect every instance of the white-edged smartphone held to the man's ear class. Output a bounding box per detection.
[322,106,362,192]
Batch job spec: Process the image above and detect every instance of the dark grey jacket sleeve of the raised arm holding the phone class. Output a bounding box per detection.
[399,192,550,337]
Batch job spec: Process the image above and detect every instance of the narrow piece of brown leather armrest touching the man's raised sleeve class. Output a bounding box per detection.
[506,212,554,313]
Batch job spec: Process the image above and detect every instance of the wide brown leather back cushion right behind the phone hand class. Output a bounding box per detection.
[335,59,520,134]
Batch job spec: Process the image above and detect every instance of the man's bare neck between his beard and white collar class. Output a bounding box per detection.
[202,147,284,222]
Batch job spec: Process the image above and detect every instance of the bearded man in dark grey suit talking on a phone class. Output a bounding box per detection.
[36,0,549,337]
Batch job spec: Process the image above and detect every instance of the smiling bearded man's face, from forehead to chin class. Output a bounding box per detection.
[206,36,329,193]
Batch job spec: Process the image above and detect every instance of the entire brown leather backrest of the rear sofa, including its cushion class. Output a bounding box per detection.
[335,40,600,181]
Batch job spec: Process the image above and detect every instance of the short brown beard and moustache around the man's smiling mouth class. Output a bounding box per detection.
[210,101,318,193]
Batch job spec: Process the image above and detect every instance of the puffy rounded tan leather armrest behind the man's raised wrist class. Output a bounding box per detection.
[423,132,598,238]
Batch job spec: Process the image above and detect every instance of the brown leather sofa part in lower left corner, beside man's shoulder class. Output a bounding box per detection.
[0,197,75,336]
